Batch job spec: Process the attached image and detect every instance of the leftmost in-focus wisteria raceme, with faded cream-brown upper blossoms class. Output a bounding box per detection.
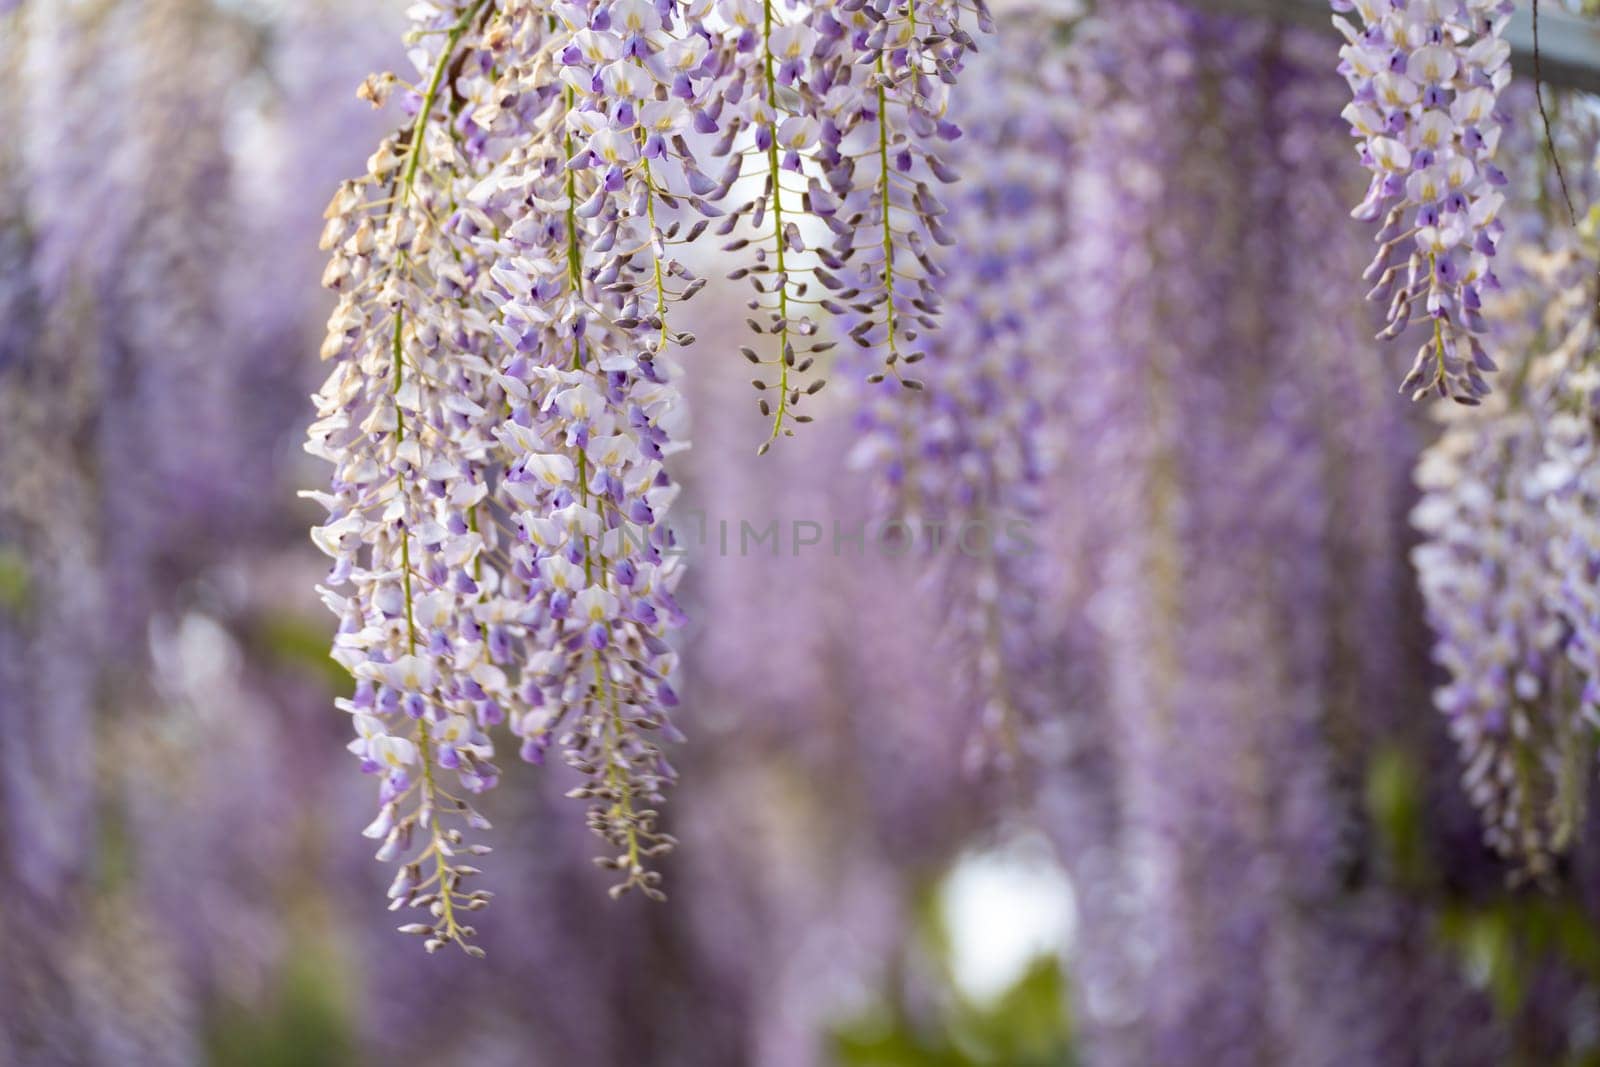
[307,0,514,952]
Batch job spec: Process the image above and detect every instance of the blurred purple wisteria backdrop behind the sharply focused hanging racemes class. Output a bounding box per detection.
[9,0,1600,1067]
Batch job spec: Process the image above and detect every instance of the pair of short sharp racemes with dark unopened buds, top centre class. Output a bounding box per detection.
[713,0,990,451]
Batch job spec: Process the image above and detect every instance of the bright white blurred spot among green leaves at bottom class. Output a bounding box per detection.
[939,835,1077,1003]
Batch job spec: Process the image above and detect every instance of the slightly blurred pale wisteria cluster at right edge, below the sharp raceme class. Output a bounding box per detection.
[1413,251,1600,878]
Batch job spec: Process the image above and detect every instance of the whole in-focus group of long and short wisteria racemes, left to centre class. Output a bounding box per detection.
[307,0,971,953]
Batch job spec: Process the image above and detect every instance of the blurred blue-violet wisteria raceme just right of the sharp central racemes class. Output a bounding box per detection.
[853,13,1077,765]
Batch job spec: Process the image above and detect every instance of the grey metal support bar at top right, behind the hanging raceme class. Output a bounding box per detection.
[1189,0,1600,93]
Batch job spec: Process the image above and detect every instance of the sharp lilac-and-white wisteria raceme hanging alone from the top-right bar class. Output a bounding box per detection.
[1333,0,1514,405]
